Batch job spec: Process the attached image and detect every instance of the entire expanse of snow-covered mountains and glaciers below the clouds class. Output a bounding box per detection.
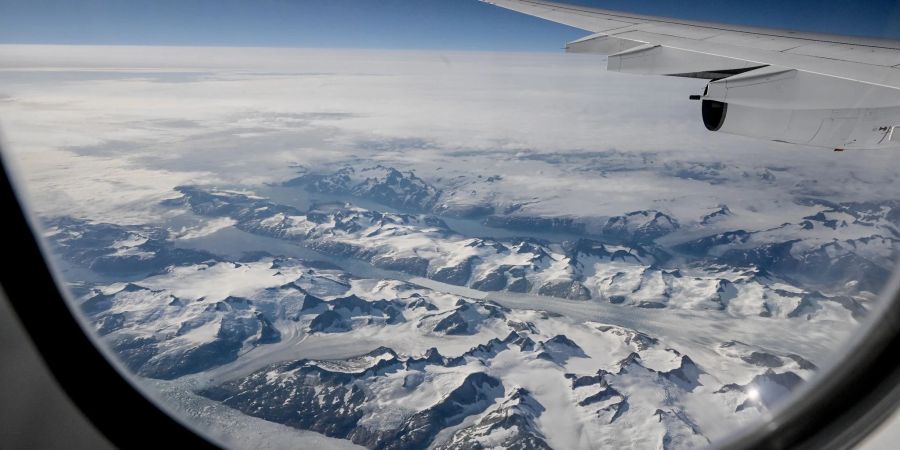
[37,156,898,449]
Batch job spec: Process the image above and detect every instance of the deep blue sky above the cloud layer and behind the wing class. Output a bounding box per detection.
[0,0,900,51]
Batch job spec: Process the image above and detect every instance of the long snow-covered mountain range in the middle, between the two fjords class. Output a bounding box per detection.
[158,187,868,318]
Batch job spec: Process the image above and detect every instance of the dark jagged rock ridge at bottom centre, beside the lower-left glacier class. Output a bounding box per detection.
[198,355,504,449]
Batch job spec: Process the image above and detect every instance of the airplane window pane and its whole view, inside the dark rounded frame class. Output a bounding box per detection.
[0,0,900,449]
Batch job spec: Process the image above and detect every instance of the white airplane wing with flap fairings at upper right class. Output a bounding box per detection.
[482,0,900,149]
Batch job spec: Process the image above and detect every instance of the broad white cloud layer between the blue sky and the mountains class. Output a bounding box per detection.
[0,46,900,223]
